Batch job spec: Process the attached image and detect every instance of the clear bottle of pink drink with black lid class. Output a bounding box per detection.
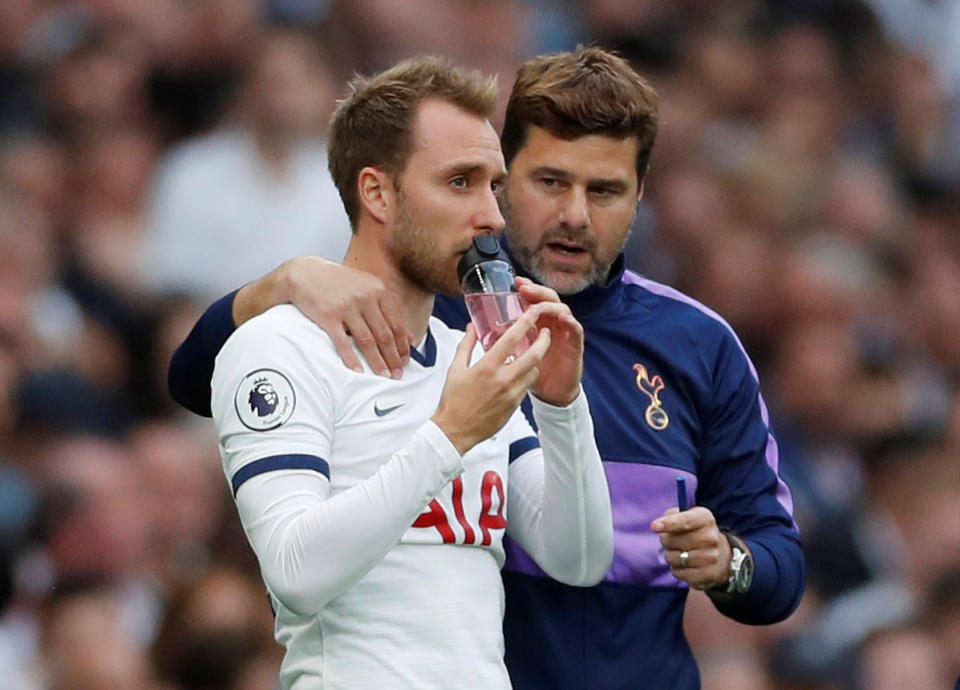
[457,235,537,359]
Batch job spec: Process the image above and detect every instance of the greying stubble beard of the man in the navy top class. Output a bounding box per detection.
[500,194,636,295]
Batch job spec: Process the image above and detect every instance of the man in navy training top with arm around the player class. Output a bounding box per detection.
[170,48,806,690]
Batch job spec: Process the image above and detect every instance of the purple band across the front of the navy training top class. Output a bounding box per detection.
[505,461,697,588]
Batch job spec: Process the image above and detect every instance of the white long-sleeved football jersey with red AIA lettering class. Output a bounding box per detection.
[212,306,612,690]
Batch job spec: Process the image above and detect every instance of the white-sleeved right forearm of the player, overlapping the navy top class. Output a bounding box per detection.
[510,392,613,586]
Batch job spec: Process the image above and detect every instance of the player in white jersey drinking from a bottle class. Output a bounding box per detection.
[211,58,613,690]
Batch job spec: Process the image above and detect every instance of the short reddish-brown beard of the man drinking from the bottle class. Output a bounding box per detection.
[387,192,461,296]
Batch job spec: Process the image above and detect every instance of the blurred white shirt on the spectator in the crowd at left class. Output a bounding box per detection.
[142,129,350,300]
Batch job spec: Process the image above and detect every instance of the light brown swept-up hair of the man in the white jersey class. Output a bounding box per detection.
[329,56,497,226]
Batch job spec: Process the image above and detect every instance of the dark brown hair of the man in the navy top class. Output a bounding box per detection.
[500,46,659,181]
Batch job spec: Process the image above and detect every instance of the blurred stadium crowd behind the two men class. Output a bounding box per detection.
[0,0,960,690]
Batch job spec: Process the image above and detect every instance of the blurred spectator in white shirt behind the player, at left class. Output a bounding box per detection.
[140,29,350,299]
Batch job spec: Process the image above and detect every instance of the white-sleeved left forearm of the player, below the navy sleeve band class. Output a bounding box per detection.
[237,422,463,614]
